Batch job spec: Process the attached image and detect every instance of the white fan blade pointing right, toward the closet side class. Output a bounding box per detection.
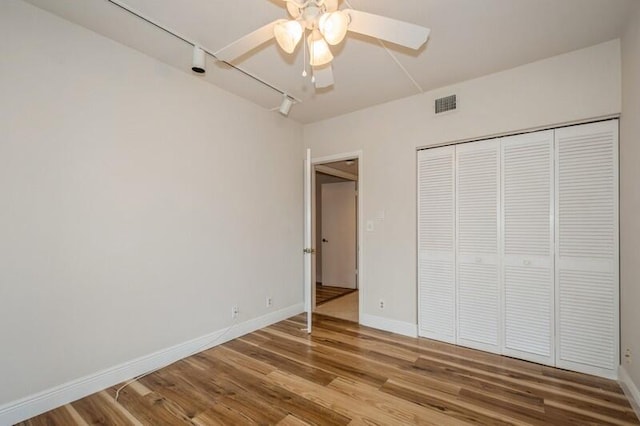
[344,9,431,49]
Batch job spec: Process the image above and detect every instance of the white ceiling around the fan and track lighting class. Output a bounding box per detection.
[27,0,638,123]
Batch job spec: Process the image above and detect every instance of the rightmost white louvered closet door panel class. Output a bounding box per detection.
[555,120,619,378]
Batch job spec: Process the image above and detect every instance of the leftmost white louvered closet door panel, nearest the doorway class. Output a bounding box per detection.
[418,146,456,343]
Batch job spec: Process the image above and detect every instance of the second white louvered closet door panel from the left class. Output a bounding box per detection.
[456,140,501,353]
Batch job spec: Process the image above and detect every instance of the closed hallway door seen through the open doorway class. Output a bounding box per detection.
[321,181,357,288]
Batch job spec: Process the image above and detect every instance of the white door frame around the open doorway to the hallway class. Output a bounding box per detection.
[311,150,366,322]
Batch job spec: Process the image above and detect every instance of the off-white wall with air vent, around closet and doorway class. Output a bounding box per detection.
[304,40,621,330]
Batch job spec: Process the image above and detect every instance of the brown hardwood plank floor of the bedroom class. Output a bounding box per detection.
[17,315,640,425]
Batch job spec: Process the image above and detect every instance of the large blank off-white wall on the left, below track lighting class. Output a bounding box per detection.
[0,0,303,410]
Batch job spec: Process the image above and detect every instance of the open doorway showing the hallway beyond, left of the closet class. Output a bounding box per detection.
[313,157,360,322]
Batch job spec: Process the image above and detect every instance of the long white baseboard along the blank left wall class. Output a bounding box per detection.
[0,303,304,425]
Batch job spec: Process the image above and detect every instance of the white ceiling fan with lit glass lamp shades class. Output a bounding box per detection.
[215,0,430,88]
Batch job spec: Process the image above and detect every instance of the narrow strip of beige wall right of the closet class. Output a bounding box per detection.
[620,3,640,389]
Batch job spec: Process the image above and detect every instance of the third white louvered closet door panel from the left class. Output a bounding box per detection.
[501,130,555,365]
